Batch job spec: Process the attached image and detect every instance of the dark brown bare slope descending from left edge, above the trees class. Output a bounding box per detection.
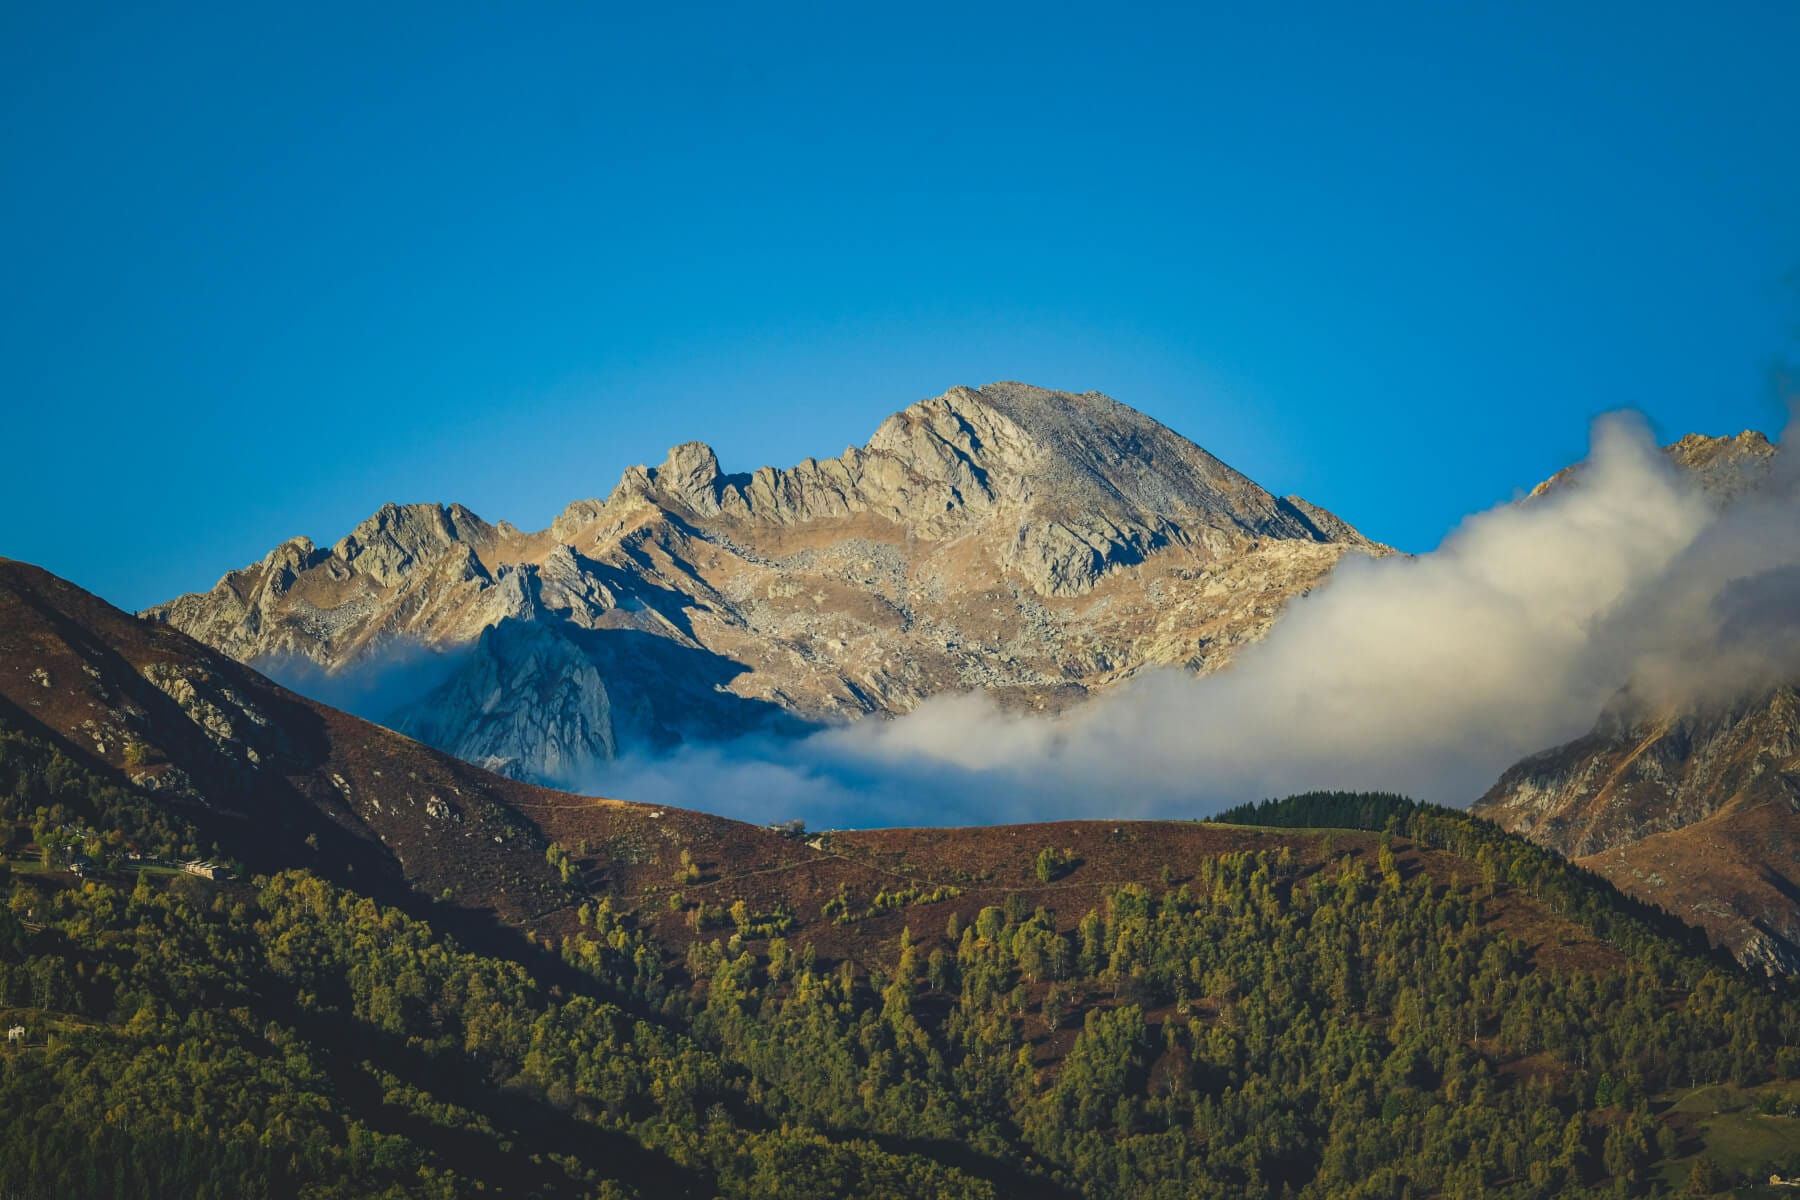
[0,560,563,919]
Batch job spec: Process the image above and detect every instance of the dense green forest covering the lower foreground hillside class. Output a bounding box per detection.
[0,734,1800,1198]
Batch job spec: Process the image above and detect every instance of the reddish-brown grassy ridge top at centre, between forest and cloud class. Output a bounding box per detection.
[527,801,1620,970]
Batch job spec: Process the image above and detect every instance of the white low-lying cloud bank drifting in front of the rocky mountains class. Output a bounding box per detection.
[590,416,1800,828]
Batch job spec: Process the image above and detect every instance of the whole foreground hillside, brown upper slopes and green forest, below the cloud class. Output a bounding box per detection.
[0,560,1800,1200]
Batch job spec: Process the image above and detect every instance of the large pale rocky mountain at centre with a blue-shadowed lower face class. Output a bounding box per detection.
[146,383,1386,783]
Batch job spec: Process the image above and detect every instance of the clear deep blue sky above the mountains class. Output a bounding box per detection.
[0,2,1800,606]
